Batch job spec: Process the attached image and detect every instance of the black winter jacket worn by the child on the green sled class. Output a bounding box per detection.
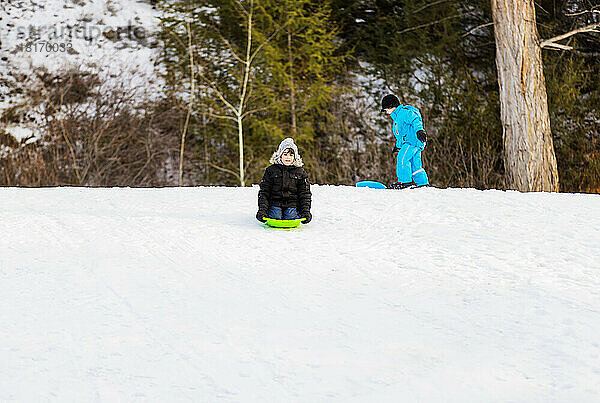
[258,164,312,217]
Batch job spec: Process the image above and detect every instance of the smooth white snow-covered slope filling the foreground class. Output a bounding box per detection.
[0,186,600,402]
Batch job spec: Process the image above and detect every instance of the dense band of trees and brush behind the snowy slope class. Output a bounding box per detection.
[0,0,600,193]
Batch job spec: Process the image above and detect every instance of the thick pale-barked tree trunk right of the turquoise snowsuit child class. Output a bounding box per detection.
[492,0,558,192]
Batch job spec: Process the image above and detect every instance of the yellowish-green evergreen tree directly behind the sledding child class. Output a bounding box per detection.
[253,0,347,179]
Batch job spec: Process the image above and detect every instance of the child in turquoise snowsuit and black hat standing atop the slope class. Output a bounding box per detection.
[381,94,429,189]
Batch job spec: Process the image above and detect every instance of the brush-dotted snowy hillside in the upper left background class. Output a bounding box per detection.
[0,0,163,140]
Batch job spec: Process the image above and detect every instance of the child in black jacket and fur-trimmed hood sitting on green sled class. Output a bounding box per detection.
[256,137,312,224]
